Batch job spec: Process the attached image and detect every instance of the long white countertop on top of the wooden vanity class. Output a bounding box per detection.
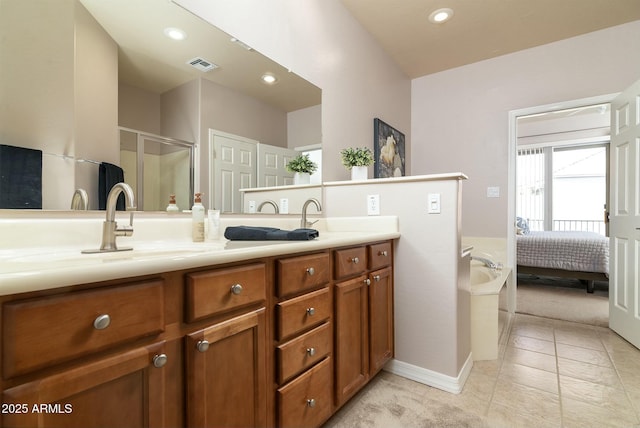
[0,217,400,295]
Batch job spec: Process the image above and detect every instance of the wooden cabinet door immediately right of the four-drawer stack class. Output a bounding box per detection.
[335,275,369,405]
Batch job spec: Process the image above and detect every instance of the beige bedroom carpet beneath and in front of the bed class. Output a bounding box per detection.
[516,275,609,327]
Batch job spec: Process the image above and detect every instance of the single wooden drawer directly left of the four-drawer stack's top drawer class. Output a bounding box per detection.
[186,263,267,322]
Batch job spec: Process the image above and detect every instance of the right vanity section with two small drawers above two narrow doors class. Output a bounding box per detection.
[334,242,393,406]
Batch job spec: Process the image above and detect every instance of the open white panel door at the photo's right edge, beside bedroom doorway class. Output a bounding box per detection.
[609,77,640,348]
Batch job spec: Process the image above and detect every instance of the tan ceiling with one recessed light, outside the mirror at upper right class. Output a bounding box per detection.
[341,0,640,79]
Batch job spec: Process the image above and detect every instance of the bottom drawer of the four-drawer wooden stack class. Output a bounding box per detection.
[278,357,333,427]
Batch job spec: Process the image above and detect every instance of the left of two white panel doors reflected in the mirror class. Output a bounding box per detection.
[209,130,258,213]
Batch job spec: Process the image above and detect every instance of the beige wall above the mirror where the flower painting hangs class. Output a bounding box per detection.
[175,0,412,181]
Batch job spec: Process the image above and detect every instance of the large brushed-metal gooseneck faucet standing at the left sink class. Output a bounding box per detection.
[82,183,136,254]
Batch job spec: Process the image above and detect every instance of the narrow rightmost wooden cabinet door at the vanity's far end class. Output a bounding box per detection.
[369,268,393,376]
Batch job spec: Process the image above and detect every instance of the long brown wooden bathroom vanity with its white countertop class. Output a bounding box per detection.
[0,216,399,427]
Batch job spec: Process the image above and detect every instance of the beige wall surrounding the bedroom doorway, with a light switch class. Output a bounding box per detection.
[410,21,640,237]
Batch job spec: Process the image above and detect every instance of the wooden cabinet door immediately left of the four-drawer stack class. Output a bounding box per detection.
[186,308,267,427]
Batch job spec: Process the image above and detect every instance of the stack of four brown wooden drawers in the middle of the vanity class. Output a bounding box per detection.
[275,251,334,428]
